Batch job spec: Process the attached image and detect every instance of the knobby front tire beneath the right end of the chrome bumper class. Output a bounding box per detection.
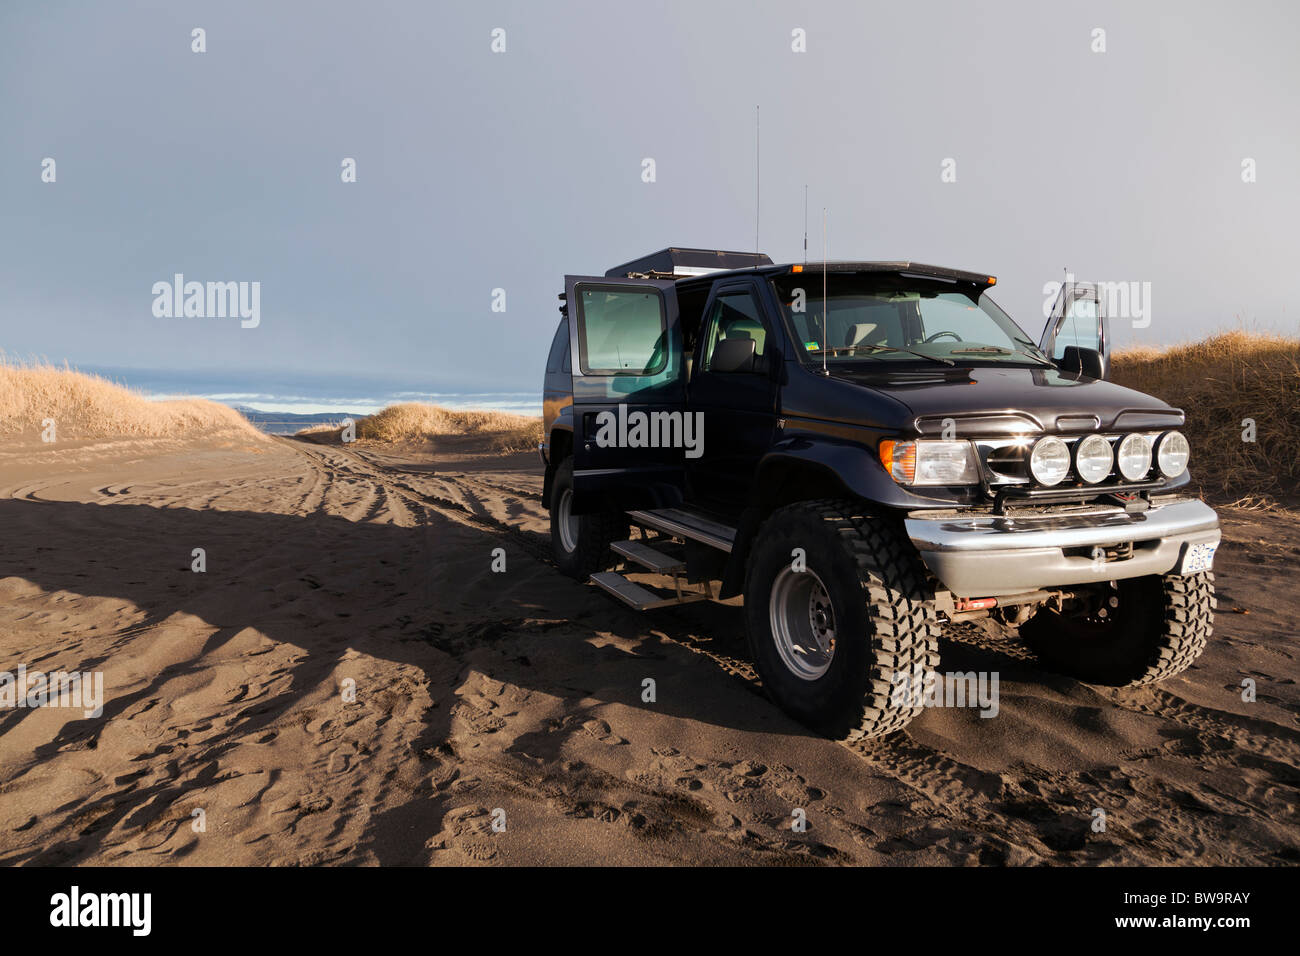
[1021,571,1217,687]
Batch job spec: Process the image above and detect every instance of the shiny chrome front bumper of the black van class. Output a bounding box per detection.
[904,498,1219,597]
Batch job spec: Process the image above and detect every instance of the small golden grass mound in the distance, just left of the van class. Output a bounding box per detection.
[299,402,542,454]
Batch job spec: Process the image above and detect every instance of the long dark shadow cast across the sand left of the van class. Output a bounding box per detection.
[0,499,925,865]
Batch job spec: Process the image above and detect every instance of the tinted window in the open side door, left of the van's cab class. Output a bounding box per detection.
[579,286,668,375]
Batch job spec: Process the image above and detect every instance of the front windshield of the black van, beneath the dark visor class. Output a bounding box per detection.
[772,272,1050,365]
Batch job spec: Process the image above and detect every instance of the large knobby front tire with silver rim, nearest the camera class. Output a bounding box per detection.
[745,501,940,740]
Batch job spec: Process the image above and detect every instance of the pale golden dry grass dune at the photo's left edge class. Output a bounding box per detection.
[0,356,264,440]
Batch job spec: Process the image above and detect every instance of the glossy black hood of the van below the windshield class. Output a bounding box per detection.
[831,363,1183,437]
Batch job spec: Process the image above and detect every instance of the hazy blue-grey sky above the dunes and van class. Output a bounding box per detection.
[0,0,1300,392]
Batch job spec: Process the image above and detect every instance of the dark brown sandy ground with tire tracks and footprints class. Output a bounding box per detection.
[0,438,1300,865]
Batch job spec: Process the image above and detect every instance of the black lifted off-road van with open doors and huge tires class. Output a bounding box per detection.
[541,248,1219,737]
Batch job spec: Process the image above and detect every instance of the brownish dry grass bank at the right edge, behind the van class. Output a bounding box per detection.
[1112,329,1300,502]
